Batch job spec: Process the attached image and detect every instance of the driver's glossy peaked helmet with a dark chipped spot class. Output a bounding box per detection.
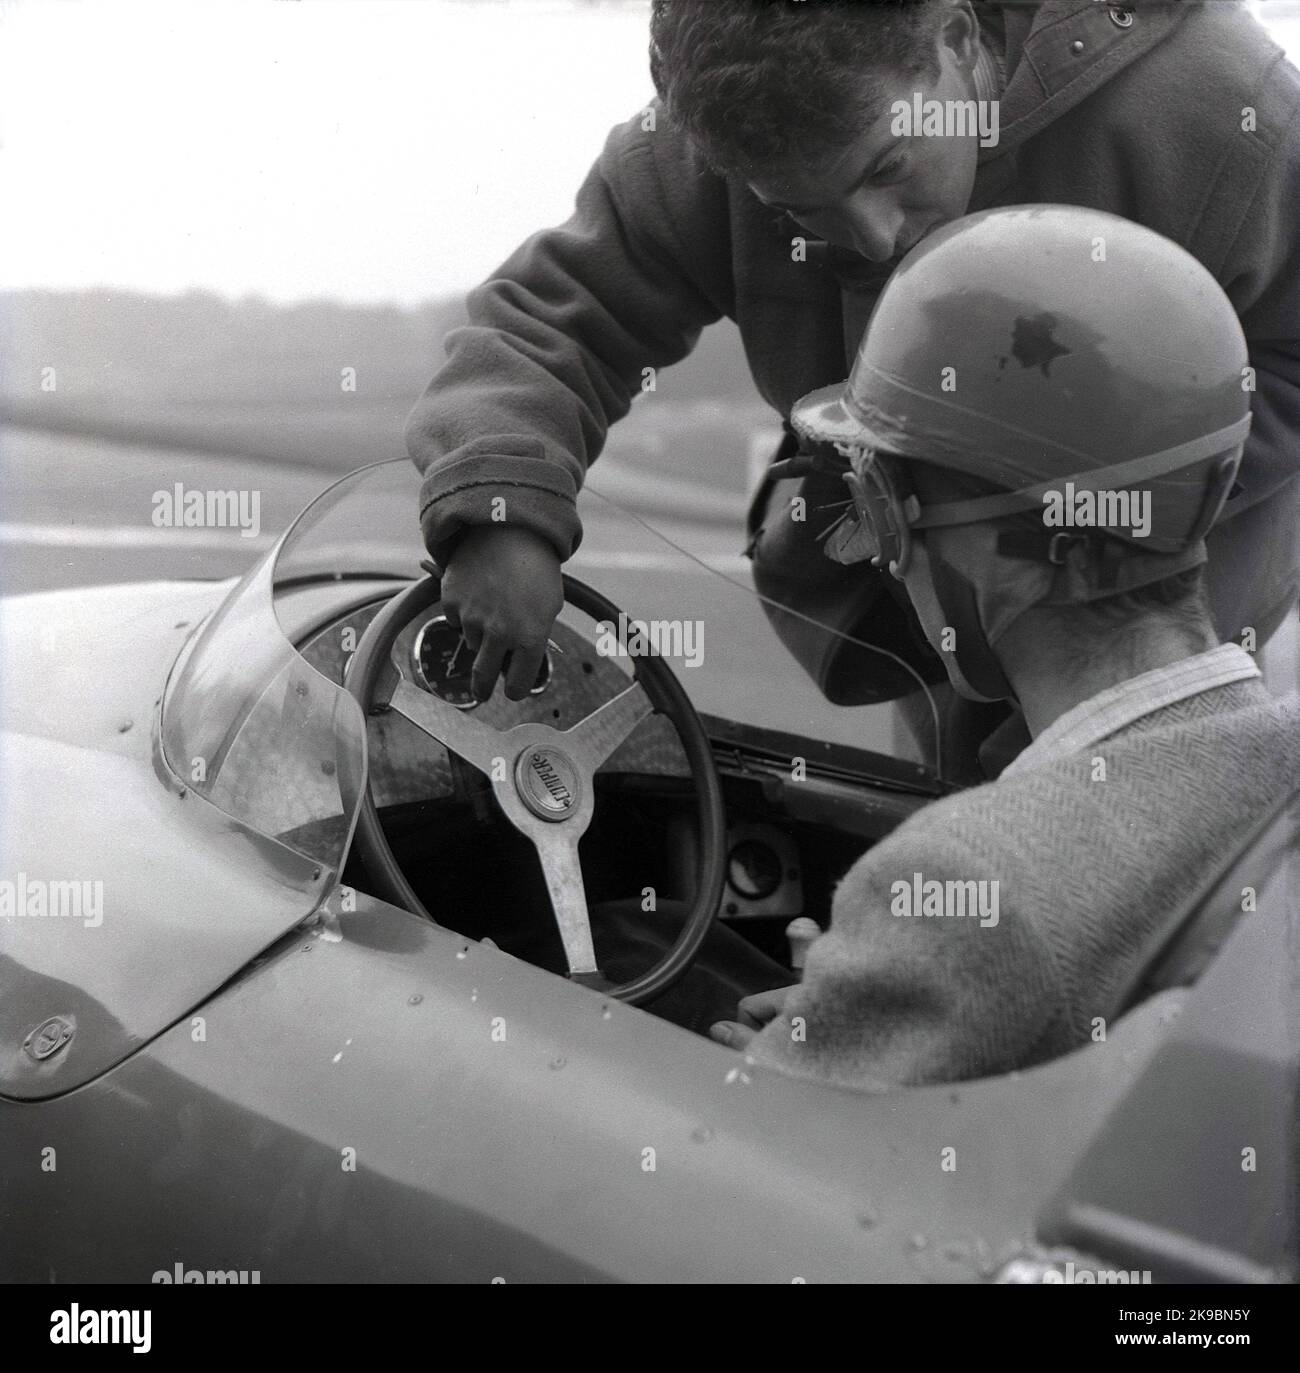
[791,205,1252,699]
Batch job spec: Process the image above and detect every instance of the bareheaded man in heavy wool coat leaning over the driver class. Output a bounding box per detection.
[408,0,1300,781]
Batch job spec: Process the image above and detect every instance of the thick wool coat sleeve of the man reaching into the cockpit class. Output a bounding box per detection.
[406,103,728,563]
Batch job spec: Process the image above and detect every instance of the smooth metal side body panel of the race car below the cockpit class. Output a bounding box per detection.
[3,892,1178,1282]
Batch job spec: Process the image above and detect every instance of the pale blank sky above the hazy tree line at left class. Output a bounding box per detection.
[0,0,1300,305]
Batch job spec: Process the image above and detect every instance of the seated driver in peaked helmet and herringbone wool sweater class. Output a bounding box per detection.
[714,206,1300,1086]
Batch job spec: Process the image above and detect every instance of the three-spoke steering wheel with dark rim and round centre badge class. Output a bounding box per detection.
[345,577,726,1005]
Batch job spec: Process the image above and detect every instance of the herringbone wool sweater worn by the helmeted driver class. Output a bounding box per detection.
[748,680,1300,1089]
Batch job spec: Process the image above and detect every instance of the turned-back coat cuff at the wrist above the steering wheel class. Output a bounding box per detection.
[420,456,582,568]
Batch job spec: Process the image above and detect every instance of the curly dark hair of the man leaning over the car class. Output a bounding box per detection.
[651,0,943,174]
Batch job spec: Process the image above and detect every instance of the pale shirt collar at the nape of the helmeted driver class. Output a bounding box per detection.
[1001,644,1260,777]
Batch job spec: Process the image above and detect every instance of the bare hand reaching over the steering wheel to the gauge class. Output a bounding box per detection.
[442,524,564,700]
